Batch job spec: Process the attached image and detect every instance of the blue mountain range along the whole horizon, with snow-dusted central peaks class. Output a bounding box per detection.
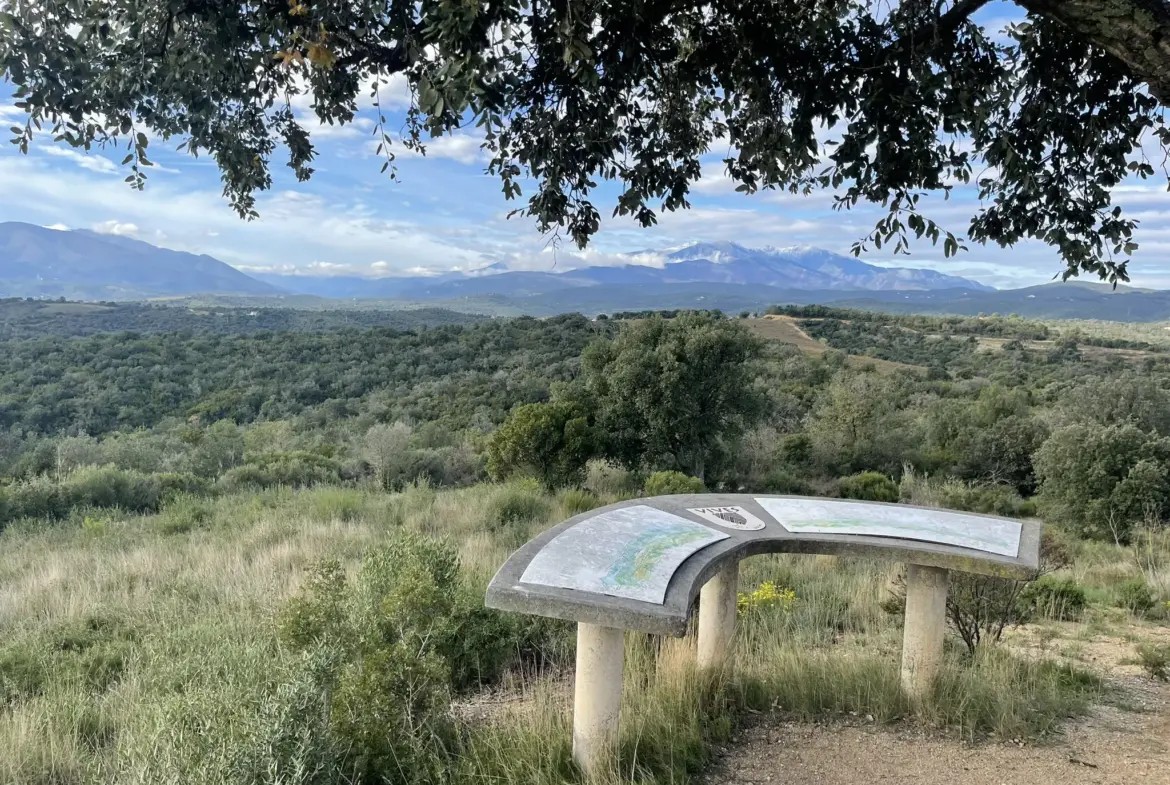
[0,222,1170,322]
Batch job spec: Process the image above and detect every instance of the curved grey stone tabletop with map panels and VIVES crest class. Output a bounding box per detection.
[487,494,1040,635]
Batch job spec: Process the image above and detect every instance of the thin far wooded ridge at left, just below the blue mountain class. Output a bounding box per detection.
[0,297,487,339]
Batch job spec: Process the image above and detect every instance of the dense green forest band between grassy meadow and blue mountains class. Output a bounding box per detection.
[0,307,1170,547]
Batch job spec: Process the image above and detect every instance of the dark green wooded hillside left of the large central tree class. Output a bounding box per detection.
[0,316,606,435]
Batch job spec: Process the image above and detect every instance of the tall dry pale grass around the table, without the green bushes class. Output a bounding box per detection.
[0,482,1137,785]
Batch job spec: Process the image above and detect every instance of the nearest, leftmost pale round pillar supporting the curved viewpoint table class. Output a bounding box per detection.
[573,624,626,778]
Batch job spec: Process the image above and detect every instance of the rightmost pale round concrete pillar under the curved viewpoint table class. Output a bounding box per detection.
[902,564,950,701]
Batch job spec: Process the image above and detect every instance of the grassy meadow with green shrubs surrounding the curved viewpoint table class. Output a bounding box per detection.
[0,481,1170,785]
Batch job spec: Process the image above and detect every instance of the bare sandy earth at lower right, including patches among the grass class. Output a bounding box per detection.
[456,622,1170,785]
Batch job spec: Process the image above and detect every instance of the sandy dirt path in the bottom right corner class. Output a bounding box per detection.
[703,679,1170,785]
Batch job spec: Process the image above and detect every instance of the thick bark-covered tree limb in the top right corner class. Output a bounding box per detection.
[1017,0,1170,105]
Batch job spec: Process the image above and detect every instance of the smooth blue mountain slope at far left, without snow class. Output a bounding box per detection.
[0,222,281,299]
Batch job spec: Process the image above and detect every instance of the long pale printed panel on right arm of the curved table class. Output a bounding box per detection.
[756,496,1023,557]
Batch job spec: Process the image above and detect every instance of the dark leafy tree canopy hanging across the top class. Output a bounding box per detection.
[0,0,1170,281]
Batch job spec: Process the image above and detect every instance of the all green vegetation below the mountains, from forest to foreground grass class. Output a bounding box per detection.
[0,308,1170,785]
